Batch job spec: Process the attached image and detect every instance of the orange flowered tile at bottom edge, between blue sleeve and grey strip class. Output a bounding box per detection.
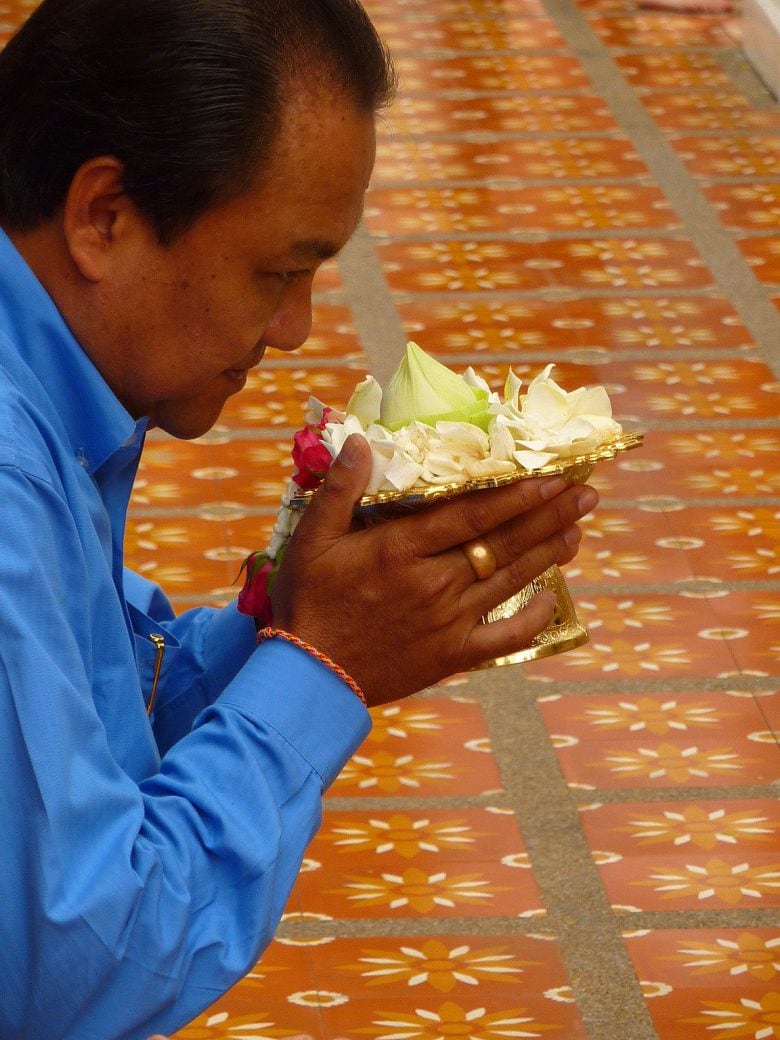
[208,934,584,1040]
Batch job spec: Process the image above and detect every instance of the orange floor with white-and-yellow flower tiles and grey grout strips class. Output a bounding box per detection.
[0,0,780,1040]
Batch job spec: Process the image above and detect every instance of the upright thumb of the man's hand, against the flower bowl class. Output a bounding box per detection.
[298,434,371,541]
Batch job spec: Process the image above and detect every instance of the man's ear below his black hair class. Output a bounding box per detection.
[62,156,135,282]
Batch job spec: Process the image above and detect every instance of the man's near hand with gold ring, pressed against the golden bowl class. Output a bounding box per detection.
[272,435,598,705]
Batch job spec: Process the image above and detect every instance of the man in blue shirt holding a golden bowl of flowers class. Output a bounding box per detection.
[0,0,595,1040]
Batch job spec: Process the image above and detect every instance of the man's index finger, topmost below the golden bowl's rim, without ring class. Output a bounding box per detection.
[399,476,569,556]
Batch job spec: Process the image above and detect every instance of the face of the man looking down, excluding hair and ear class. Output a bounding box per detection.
[87,91,374,438]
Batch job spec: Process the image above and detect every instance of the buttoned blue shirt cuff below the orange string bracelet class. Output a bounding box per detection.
[219,640,371,787]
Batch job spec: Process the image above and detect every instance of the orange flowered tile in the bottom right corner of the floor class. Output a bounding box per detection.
[625,928,780,1040]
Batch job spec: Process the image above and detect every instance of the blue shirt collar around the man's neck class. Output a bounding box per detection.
[0,229,149,473]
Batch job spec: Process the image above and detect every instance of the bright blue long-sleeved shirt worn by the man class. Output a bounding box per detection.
[0,232,370,1040]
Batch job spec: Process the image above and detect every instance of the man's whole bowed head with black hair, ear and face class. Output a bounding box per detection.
[0,0,394,437]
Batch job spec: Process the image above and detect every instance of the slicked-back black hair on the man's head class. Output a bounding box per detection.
[0,0,395,242]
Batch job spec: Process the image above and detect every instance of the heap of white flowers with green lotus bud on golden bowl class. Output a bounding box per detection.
[307,343,621,495]
